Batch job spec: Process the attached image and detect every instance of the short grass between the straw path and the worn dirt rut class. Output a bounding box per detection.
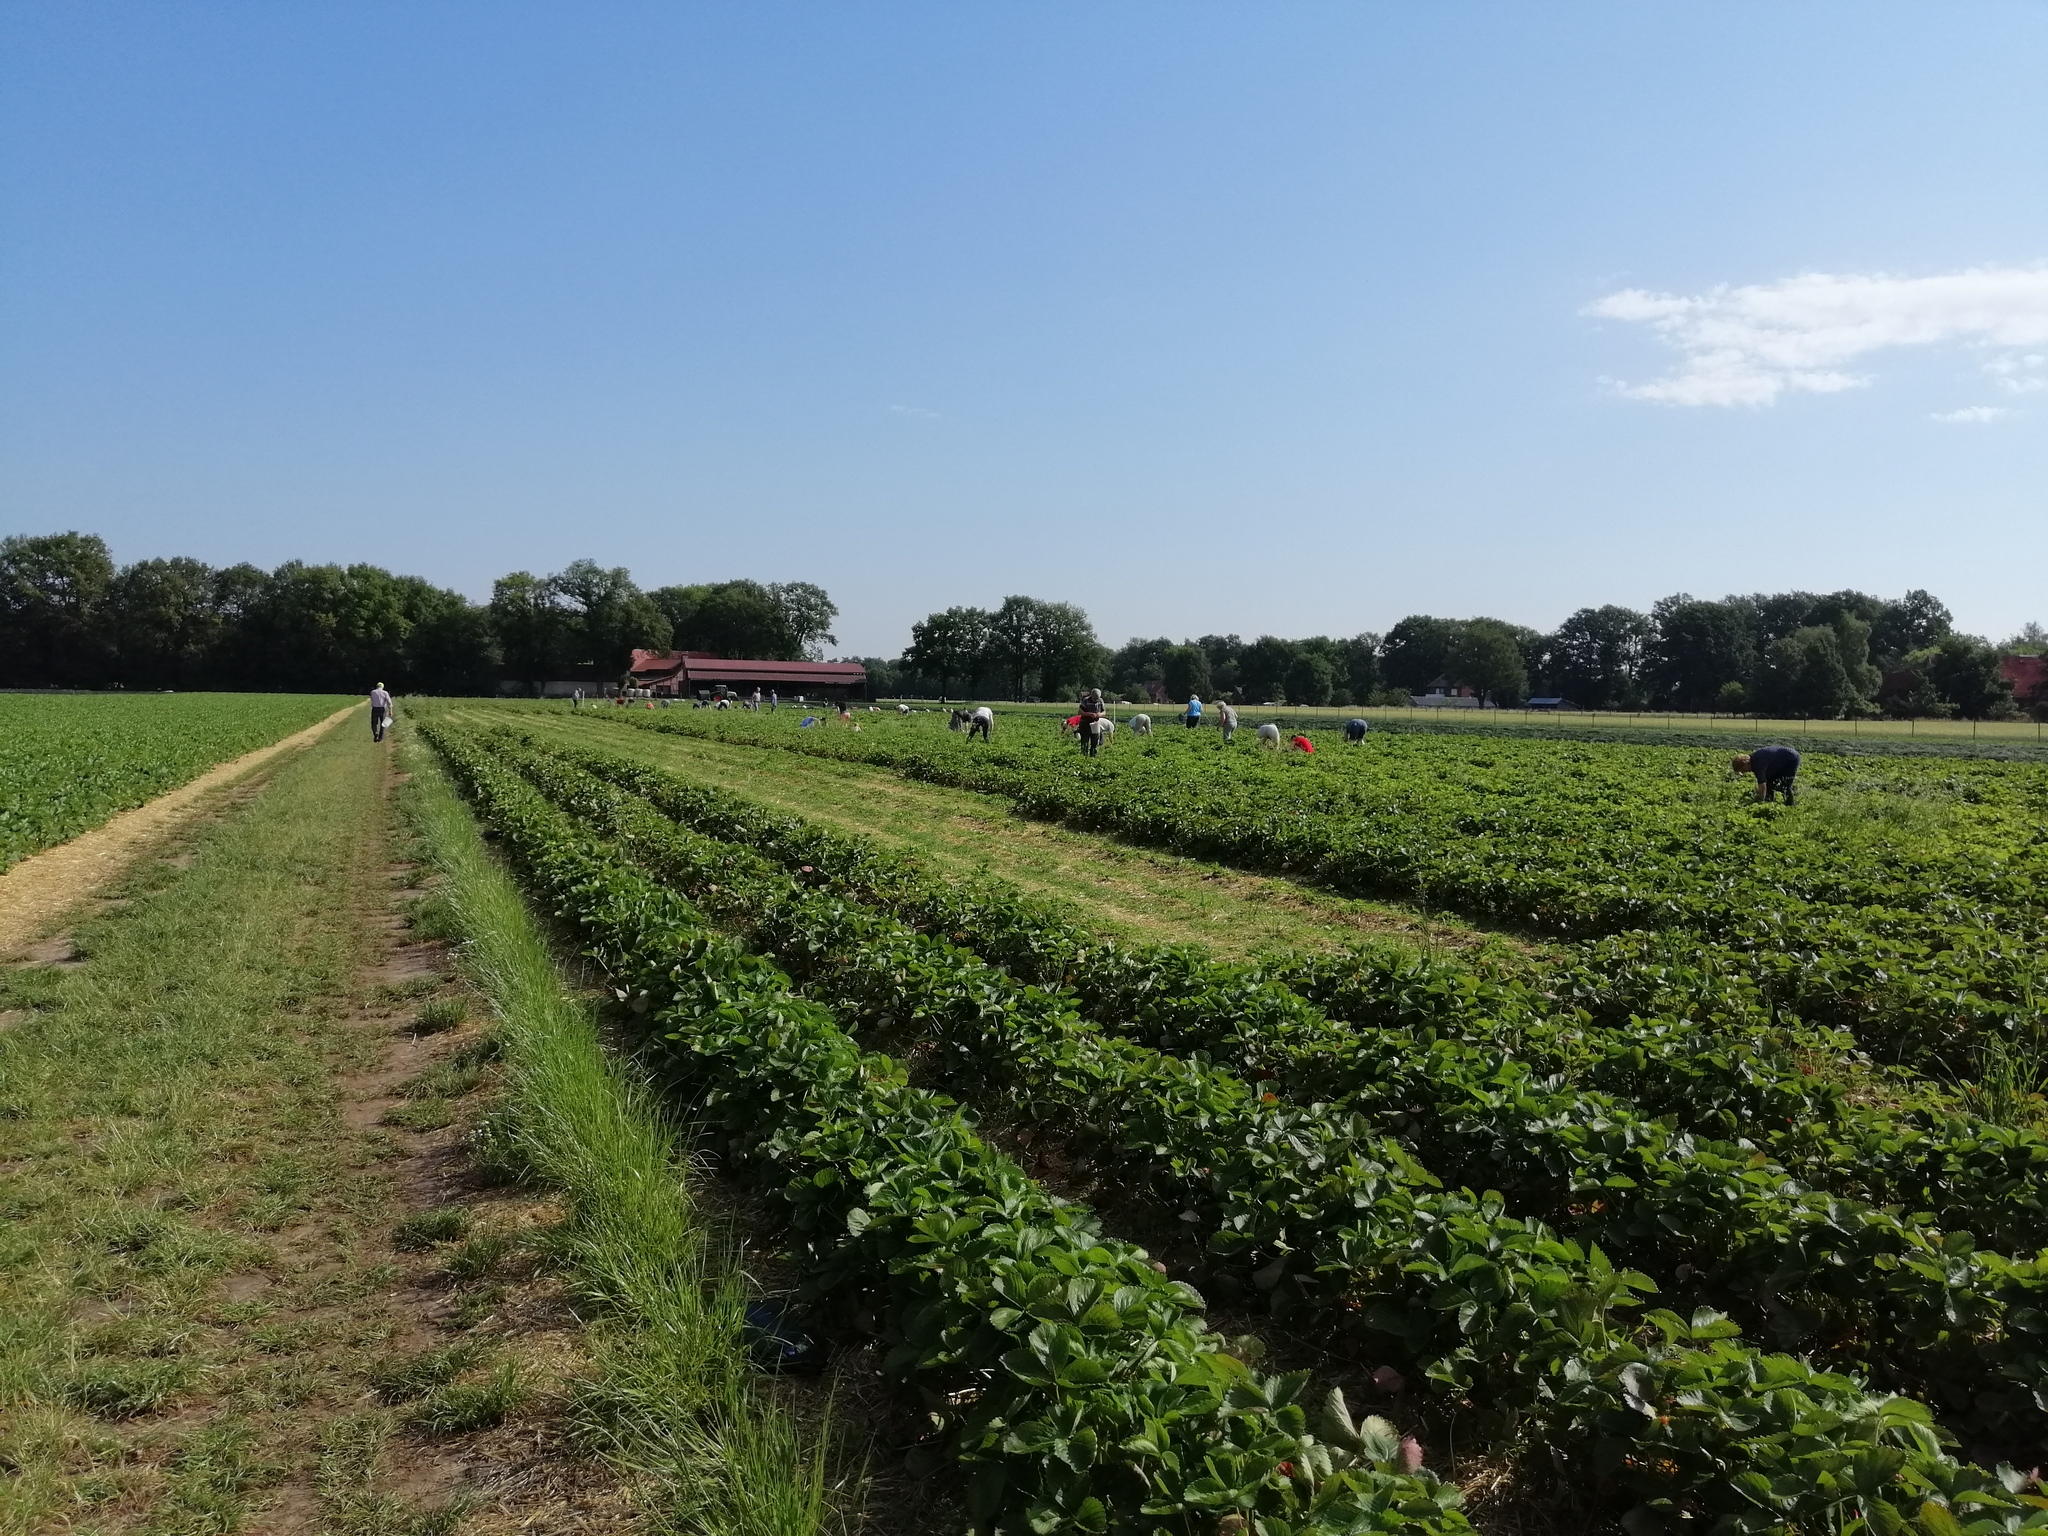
[0,729,393,1536]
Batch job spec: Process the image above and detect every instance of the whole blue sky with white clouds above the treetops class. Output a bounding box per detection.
[0,0,2048,653]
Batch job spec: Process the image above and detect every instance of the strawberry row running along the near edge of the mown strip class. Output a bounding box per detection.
[532,741,2048,1249]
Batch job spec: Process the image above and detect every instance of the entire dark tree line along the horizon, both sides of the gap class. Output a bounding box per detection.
[0,532,2048,719]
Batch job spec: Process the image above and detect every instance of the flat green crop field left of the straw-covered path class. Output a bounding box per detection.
[0,694,354,870]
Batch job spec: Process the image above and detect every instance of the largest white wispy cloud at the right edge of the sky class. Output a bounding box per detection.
[1585,266,2048,406]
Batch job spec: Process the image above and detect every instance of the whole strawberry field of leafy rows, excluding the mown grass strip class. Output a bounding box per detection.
[426,709,2048,1536]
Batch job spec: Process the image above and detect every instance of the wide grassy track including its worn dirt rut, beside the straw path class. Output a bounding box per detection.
[0,731,639,1536]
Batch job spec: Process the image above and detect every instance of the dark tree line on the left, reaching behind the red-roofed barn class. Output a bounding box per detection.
[0,532,838,694]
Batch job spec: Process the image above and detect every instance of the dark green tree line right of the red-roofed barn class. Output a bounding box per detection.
[884,592,2048,719]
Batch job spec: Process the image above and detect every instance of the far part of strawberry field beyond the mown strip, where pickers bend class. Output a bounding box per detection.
[544,707,2048,1063]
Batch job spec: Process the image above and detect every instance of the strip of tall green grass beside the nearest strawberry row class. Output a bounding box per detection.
[406,729,850,1536]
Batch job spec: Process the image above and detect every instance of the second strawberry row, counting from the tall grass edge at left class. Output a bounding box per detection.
[464,724,2048,1528]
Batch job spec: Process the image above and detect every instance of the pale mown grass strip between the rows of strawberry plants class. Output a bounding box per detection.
[487,711,1513,956]
